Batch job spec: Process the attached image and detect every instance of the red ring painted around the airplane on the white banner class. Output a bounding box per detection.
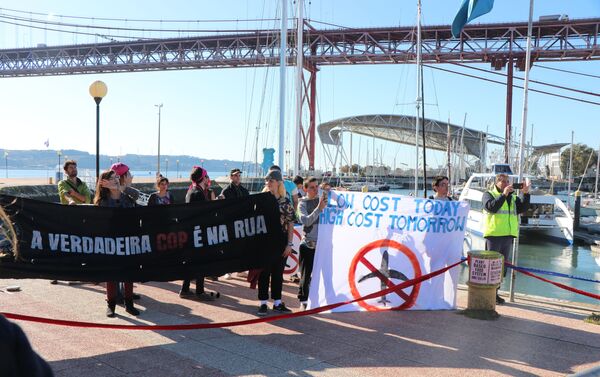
[348,239,421,311]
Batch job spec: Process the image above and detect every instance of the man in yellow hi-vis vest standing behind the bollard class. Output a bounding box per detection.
[482,174,530,304]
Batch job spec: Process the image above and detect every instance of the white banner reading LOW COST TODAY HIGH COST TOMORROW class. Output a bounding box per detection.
[309,191,469,311]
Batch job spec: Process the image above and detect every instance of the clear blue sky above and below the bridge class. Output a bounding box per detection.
[0,0,600,173]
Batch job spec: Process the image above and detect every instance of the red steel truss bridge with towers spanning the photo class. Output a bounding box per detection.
[0,18,600,170]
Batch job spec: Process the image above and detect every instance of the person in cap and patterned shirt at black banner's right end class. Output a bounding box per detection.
[256,170,296,316]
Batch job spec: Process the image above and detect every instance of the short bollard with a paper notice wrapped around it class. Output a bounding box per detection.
[467,250,504,313]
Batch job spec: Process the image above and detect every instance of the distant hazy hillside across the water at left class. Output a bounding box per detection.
[0,149,254,172]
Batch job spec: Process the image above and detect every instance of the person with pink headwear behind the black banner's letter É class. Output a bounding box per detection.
[179,166,215,301]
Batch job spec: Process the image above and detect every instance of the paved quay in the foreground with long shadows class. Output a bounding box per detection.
[0,277,600,377]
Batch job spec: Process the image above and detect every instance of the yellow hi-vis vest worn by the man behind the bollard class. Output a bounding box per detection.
[483,186,519,237]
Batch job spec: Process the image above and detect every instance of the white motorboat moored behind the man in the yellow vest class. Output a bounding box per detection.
[459,166,573,250]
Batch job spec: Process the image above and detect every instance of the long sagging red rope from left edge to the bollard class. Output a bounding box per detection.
[0,260,463,331]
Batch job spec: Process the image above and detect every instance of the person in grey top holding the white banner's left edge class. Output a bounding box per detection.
[298,177,329,309]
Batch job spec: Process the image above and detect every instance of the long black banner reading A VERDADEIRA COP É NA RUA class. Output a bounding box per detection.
[0,193,286,281]
